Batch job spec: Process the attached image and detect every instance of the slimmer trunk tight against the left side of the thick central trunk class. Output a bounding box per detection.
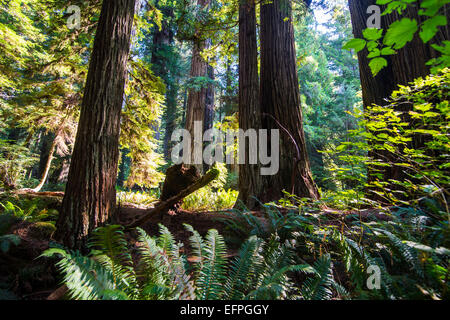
[236,0,264,209]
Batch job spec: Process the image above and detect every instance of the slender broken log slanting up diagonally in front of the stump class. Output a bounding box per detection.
[126,168,219,229]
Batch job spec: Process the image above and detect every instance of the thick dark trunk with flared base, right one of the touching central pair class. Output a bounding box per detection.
[261,0,319,201]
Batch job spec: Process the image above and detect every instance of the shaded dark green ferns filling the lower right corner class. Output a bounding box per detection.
[225,198,450,299]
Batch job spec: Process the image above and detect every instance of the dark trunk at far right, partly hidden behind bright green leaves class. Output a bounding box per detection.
[348,0,450,200]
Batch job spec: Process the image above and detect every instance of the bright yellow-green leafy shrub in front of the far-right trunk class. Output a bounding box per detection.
[326,68,450,208]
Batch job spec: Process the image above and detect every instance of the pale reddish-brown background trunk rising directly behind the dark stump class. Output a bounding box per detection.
[185,0,211,171]
